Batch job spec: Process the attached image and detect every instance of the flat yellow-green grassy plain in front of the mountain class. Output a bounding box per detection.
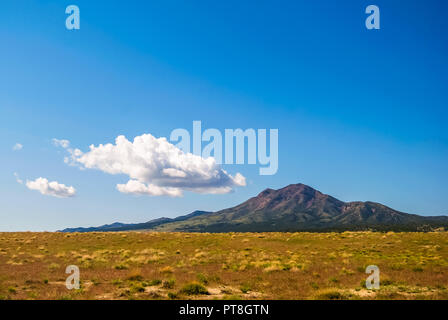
[0,232,448,299]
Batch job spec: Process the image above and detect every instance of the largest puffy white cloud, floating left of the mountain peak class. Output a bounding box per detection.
[64,134,246,197]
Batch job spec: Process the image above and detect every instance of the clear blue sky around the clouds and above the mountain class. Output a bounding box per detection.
[0,0,448,231]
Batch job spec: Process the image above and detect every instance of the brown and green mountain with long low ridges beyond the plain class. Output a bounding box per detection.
[63,184,448,232]
